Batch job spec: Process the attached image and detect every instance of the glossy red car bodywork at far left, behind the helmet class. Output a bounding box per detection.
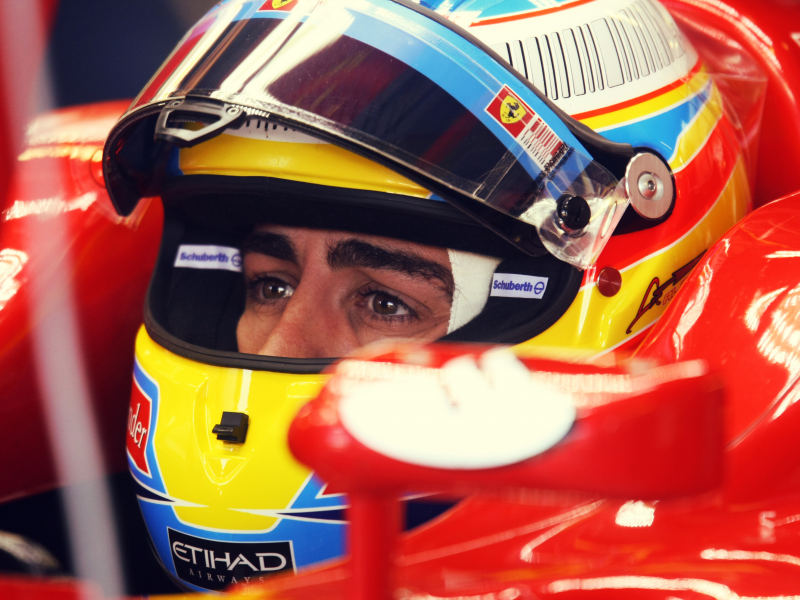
[0,102,161,499]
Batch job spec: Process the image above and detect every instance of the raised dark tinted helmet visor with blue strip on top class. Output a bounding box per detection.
[105,0,628,268]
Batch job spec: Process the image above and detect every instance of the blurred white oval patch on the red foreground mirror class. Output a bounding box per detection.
[339,349,575,469]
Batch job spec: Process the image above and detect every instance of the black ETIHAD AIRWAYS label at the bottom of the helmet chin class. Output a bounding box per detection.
[167,528,294,590]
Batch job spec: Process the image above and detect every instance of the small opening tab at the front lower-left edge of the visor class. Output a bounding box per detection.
[155,98,247,148]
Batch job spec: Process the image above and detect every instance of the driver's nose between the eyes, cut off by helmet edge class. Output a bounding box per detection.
[258,280,357,358]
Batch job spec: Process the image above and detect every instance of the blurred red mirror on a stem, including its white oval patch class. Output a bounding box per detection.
[289,345,723,600]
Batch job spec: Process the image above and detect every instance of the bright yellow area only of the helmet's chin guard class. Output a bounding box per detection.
[136,328,325,532]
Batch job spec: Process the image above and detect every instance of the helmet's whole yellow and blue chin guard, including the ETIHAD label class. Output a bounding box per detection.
[127,328,346,591]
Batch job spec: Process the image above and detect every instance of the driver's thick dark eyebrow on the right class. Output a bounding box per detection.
[328,238,455,298]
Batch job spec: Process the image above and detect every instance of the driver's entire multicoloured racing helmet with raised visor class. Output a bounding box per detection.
[103,0,750,590]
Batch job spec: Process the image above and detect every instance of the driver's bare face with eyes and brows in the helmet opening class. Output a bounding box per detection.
[236,225,453,358]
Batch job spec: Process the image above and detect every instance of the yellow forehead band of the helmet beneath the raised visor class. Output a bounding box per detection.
[179,121,430,198]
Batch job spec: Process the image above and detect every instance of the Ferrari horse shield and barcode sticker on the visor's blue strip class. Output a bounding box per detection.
[486,86,568,174]
